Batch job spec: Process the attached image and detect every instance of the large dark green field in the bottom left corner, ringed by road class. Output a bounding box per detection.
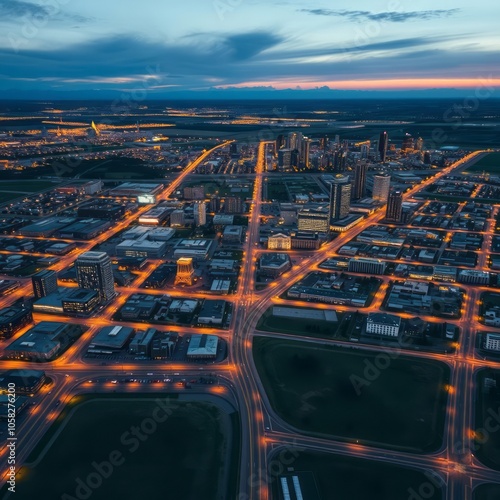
[7,394,238,500]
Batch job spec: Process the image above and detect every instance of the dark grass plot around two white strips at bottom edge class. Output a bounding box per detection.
[271,448,442,500]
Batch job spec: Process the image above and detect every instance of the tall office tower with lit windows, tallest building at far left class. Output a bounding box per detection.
[75,252,116,302]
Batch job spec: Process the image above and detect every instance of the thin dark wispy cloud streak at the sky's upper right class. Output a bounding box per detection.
[299,9,460,23]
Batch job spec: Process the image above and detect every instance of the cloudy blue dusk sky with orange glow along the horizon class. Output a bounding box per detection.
[0,0,500,98]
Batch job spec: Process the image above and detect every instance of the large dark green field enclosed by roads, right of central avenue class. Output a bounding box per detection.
[253,337,450,453]
